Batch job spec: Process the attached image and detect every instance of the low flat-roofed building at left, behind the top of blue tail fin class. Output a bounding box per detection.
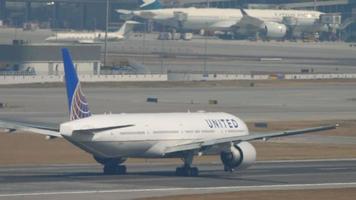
[0,41,100,75]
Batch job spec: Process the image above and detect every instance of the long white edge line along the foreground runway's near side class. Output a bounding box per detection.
[0,182,356,197]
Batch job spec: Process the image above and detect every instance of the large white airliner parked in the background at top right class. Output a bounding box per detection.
[117,0,323,38]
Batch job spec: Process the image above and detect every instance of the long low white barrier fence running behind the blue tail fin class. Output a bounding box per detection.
[0,73,356,85]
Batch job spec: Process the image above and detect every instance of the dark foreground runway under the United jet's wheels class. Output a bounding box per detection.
[0,160,356,200]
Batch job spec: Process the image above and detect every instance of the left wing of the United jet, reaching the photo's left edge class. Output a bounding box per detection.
[0,120,62,138]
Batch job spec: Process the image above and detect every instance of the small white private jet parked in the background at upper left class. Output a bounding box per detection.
[45,21,139,44]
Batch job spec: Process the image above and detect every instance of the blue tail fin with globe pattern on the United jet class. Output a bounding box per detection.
[62,48,91,120]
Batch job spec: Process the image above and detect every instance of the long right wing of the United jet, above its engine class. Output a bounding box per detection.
[165,124,338,154]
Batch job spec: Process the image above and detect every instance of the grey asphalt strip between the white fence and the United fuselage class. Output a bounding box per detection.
[0,83,356,123]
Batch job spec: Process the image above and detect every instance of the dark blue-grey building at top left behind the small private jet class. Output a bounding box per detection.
[0,0,138,29]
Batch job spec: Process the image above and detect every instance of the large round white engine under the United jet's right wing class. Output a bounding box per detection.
[220,142,256,171]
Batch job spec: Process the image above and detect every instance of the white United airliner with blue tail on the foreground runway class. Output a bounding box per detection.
[0,49,337,176]
